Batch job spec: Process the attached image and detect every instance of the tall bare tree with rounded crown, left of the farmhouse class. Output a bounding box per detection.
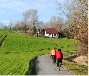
[23,9,38,33]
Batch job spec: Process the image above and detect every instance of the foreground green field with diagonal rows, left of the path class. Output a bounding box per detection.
[0,52,32,75]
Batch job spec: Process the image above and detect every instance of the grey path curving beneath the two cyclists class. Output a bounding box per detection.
[36,54,73,75]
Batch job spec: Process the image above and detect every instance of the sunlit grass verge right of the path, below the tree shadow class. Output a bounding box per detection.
[63,60,88,75]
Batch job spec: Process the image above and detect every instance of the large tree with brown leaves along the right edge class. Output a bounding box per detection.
[57,0,88,55]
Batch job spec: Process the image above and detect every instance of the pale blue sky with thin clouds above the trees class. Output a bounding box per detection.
[0,0,66,24]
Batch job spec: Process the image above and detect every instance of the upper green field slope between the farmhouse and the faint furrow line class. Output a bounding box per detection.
[1,33,77,52]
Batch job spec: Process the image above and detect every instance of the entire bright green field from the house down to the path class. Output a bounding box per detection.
[0,29,87,75]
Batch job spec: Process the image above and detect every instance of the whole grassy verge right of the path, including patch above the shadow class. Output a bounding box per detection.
[63,52,88,75]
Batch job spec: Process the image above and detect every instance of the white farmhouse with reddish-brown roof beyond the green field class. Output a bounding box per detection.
[45,28,58,37]
